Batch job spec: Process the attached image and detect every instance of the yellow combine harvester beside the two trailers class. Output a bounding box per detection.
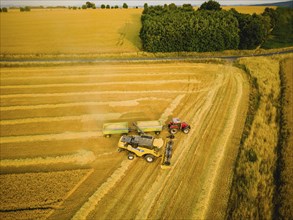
[118,123,174,168]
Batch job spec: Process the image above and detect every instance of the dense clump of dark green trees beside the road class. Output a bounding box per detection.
[140,0,278,52]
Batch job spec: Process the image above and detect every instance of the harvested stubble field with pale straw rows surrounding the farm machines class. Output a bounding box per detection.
[0,63,248,219]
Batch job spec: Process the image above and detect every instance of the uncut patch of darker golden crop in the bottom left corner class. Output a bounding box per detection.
[0,169,93,211]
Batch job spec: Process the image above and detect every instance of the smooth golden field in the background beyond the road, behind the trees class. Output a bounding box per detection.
[0,6,274,54]
